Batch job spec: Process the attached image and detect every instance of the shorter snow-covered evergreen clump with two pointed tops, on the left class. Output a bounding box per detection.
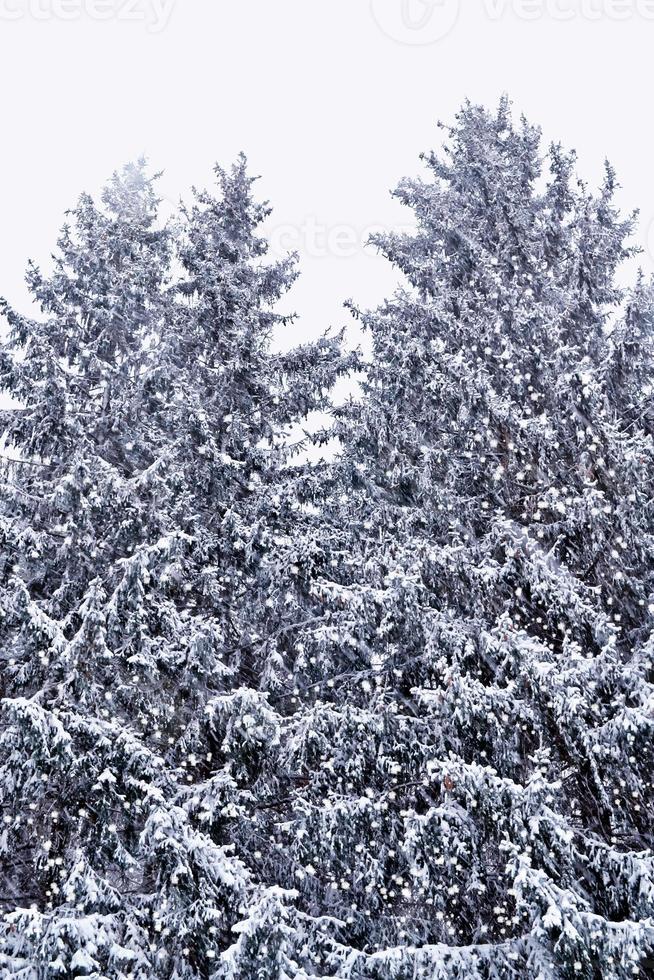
[0,159,350,980]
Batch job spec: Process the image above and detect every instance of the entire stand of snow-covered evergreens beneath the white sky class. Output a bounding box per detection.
[0,102,654,980]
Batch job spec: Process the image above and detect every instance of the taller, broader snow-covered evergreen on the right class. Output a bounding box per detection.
[236,101,654,980]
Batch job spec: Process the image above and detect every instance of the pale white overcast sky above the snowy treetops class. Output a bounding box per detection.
[0,0,654,352]
